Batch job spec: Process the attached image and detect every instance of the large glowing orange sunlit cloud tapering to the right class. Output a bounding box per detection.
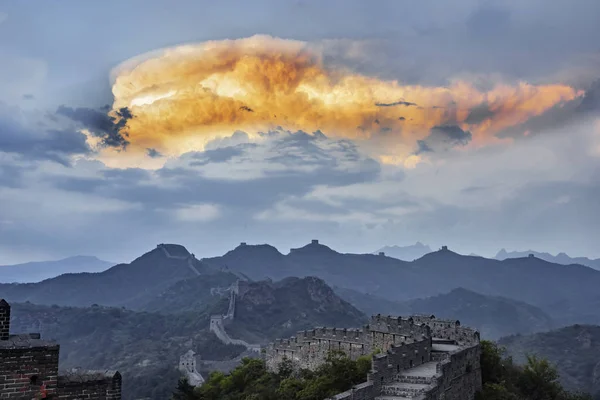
[112,36,579,165]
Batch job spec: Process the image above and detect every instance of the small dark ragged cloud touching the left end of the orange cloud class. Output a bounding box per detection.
[56,105,133,148]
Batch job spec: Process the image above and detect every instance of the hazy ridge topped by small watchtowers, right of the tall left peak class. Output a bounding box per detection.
[202,241,600,325]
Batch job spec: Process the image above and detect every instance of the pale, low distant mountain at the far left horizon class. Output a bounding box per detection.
[0,256,114,283]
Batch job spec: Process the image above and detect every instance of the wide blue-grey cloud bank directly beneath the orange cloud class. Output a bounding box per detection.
[52,131,380,212]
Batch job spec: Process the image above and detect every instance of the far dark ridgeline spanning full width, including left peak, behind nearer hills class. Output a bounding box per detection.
[0,241,600,326]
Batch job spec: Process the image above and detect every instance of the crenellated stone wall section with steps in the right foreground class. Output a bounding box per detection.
[266,315,481,400]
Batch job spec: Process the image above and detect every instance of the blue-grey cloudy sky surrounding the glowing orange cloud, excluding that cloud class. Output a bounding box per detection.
[0,0,600,263]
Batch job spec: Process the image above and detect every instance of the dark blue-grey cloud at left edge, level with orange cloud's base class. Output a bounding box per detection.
[0,105,90,166]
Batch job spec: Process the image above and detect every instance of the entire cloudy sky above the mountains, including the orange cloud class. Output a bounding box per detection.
[0,0,600,265]
